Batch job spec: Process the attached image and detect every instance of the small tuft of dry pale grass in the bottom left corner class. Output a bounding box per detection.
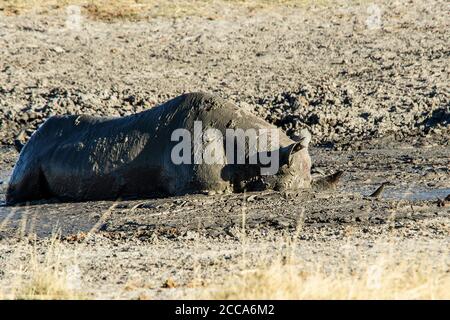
[5,237,86,300]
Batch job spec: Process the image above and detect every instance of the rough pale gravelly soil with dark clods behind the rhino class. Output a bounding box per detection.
[0,1,450,147]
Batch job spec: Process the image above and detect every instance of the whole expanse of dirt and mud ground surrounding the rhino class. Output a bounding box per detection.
[0,1,450,299]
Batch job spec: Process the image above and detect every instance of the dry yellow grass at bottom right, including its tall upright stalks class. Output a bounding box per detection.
[198,200,450,300]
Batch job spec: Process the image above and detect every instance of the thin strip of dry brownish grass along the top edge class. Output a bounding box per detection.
[0,0,362,21]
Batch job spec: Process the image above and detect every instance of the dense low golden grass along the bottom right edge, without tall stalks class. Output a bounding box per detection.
[200,244,450,300]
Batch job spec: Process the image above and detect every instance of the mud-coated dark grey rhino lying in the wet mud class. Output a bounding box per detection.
[6,92,342,205]
